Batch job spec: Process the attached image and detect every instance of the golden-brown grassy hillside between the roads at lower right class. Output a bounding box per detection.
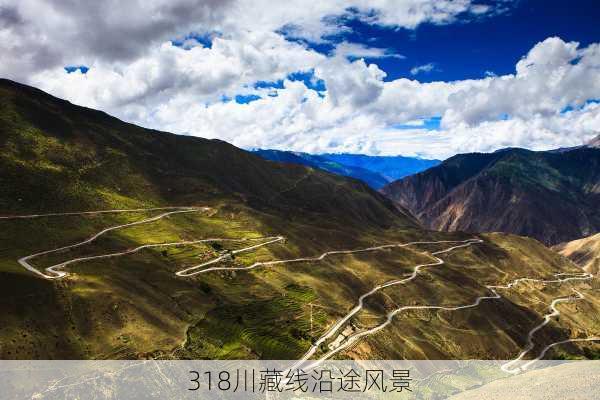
[351,234,600,359]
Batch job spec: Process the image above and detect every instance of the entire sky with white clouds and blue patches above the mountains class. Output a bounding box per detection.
[0,0,600,159]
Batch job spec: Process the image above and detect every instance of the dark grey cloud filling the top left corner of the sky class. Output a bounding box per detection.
[0,0,231,79]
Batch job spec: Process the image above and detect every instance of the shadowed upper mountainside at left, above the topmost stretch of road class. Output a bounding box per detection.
[0,80,402,225]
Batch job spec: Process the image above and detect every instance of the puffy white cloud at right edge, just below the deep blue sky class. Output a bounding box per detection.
[443,37,600,127]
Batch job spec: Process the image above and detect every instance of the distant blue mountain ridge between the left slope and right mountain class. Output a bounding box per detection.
[253,150,440,190]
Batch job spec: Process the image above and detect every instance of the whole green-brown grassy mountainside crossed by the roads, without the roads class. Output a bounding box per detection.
[0,81,599,358]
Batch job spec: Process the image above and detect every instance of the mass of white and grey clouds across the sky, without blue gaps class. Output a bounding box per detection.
[0,0,600,158]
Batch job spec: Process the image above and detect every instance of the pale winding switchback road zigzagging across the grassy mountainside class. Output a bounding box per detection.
[0,207,600,373]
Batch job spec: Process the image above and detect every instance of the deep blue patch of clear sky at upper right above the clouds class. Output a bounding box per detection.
[294,0,600,82]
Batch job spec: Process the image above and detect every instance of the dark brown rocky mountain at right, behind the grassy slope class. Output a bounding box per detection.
[382,146,600,244]
